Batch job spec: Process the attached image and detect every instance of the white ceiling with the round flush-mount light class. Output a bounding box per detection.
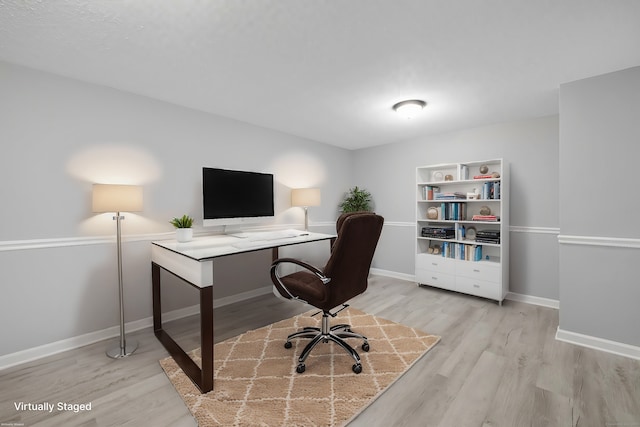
[0,0,640,149]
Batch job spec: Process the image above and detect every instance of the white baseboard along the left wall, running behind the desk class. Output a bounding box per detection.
[0,286,271,371]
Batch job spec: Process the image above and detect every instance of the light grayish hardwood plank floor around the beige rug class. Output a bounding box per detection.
[0,277,640,427]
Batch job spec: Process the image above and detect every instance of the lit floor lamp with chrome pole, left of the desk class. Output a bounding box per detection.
[93,184,142,359]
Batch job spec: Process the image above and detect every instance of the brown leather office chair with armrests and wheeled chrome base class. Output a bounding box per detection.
[271,212,384,374]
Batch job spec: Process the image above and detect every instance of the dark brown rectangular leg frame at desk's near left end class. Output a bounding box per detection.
[151,262,213,393]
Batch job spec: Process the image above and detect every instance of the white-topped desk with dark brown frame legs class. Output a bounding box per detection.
[151,231,336,393]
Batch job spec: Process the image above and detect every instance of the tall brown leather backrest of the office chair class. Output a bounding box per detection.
[323,212,384,307]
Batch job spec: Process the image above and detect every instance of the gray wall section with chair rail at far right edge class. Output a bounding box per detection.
[560,67,640,346]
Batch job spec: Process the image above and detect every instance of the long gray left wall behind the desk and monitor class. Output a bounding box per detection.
[0,62,353,356]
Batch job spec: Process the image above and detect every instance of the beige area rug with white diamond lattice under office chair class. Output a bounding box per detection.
[160,308,440,427]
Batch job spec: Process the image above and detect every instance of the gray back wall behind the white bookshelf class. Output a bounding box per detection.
[355,111,559,300]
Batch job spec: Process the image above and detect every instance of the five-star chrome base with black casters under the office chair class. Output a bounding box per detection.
[284,311,369,374]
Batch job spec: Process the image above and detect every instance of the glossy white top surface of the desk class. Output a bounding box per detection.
[152,230,336,261]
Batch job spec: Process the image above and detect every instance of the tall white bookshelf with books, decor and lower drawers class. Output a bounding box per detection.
[415,159,509,304]
